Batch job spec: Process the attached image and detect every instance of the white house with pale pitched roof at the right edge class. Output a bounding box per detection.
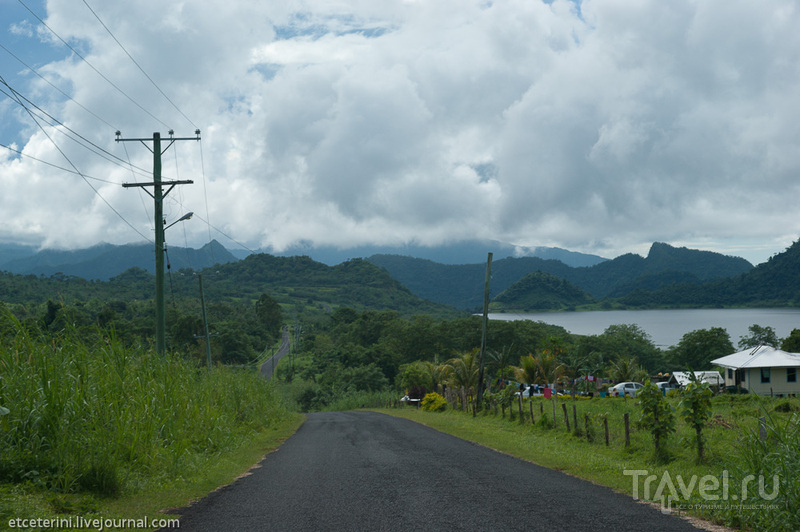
[711,345,800,396]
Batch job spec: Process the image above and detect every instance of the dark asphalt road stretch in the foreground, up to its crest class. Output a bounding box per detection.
[162,412,697,532]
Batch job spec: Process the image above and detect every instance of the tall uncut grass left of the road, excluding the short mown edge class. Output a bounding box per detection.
[0,308,290,496]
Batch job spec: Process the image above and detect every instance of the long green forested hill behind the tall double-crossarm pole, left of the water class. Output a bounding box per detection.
[0,254,459,316]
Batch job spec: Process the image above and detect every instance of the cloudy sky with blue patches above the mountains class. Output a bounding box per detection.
[0,0,800,264]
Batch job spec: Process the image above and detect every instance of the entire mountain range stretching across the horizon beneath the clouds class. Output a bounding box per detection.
[0,236,800,313]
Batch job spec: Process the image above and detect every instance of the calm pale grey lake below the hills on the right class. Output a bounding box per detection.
[489,309,800,349]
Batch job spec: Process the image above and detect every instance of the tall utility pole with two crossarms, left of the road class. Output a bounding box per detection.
[116,129,200,355]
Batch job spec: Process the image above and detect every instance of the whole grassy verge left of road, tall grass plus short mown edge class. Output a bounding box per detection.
[0,317,303,529]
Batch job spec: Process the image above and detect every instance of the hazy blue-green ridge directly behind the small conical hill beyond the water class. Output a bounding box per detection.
[367,243,753,310]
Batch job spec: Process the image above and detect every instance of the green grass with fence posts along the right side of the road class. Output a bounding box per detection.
[379,395,800,531]
